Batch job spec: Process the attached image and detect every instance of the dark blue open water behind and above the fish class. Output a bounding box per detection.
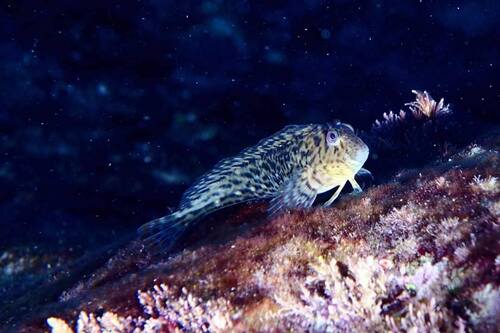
[0,1,500,322]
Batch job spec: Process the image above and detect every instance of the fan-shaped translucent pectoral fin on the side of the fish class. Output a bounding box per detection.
[268,174,317,216]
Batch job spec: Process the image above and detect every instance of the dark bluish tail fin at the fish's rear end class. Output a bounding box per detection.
[137,212,187,255]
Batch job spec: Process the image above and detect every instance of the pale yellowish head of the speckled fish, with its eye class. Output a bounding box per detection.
[325,122,370,178]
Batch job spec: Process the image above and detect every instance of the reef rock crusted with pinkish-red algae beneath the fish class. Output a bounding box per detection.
[0,92,500,333]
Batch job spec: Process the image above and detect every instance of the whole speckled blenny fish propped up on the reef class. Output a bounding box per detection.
[139,122,369,252]
